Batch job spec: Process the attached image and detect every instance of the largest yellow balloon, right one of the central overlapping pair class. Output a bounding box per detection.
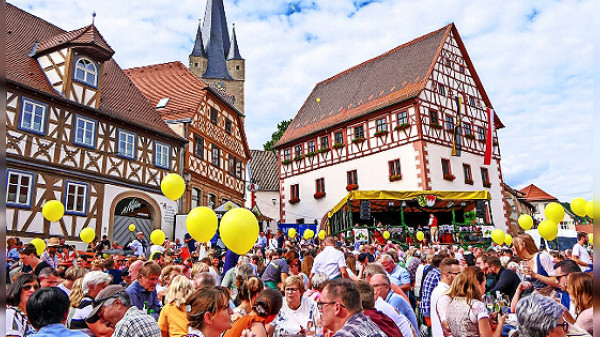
[219,207,258,255]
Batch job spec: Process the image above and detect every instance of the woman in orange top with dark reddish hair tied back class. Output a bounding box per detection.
[223,289,283,337]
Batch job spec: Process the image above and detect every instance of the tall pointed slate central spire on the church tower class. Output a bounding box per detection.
[202,0,232,79]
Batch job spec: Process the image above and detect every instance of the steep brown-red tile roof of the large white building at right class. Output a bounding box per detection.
[276,23,502,147]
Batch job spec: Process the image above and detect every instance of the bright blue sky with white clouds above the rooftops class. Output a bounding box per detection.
[10,0,594,201]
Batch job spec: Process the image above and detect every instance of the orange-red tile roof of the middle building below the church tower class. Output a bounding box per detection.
[125,61,208,120]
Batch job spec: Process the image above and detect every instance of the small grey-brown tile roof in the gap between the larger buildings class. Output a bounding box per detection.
[248,150,279,191]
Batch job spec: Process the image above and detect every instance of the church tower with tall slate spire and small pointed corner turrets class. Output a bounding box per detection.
[189,0,245,113]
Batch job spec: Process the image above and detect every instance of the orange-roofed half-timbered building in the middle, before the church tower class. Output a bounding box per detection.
[125,62,250,213]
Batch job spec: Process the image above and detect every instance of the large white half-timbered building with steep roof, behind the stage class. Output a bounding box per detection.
[276,24,506,228]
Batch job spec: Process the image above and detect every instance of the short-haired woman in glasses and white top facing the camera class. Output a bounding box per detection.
[267,275,318,337]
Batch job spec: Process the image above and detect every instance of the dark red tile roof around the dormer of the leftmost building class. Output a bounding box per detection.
[6,4,183,141]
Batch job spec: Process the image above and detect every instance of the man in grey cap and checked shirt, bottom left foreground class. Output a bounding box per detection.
[86,285,162,337]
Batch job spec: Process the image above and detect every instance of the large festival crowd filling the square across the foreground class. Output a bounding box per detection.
[6,231,593,337]
